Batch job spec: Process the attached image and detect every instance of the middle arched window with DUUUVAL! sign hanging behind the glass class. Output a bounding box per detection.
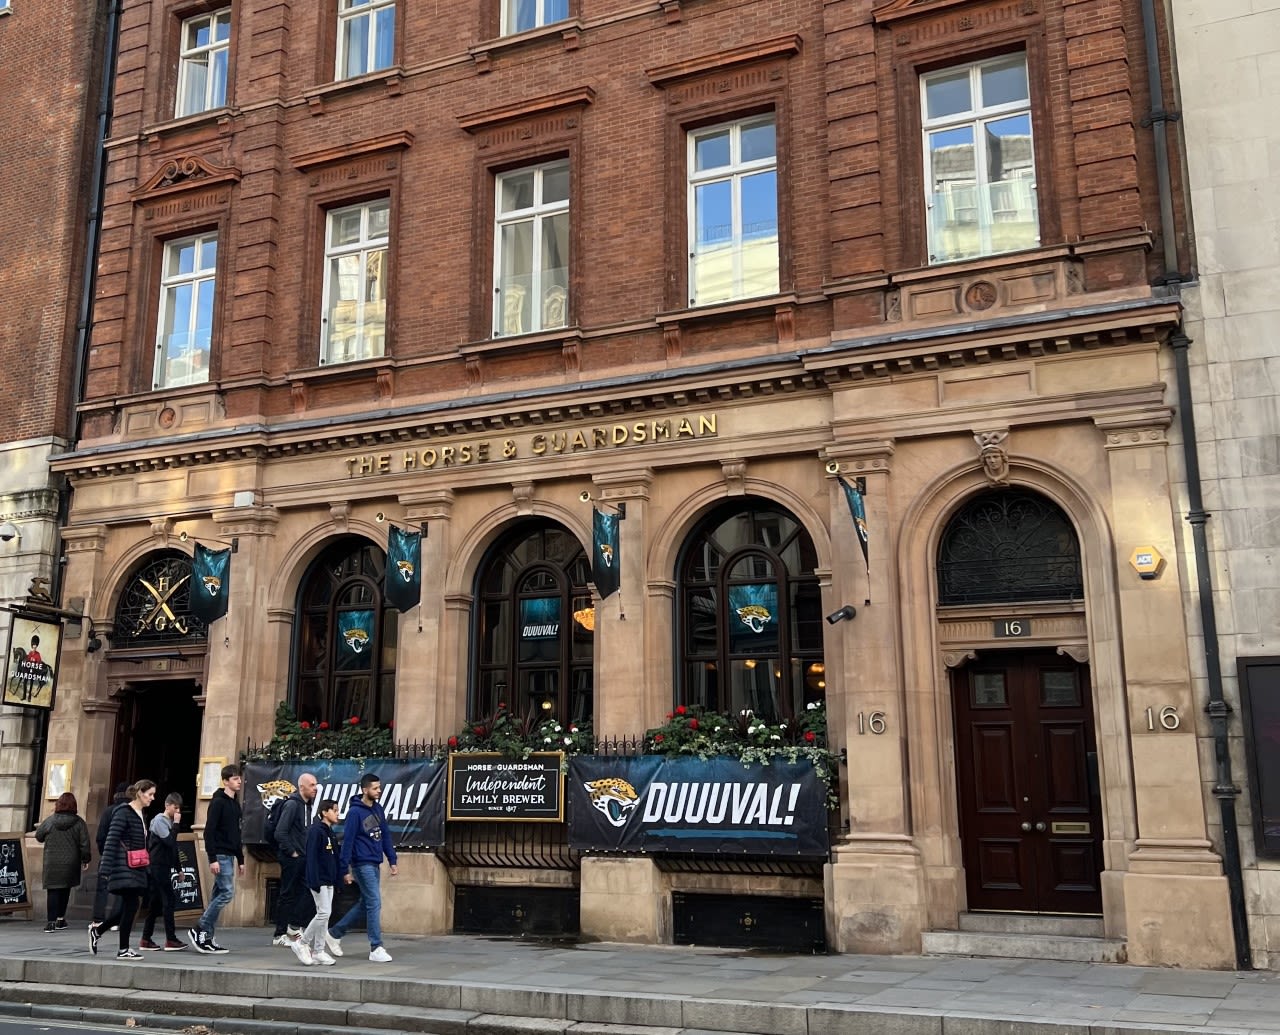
[470,521,595,723]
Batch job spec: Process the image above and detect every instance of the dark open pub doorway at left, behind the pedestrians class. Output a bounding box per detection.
[111,679,204,830]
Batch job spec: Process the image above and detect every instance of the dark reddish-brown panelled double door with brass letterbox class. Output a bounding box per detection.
[952,651,1102,913]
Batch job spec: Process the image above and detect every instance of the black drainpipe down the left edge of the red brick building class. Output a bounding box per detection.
[27,0,122,829]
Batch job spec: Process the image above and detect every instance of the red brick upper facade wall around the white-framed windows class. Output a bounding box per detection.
[77,0,1176,440]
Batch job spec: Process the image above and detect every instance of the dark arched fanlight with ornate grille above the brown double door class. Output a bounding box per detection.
[938,489,1084,604]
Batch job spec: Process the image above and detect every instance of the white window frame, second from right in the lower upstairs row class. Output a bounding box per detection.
[685,111,782,306]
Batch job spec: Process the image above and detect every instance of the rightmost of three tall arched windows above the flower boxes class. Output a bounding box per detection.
[676,499,827,720]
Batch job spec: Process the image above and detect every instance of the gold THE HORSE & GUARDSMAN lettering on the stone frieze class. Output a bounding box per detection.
[344,413,718,478]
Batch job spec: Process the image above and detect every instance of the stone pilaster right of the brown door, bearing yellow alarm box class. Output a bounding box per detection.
[1096,409,1235,967]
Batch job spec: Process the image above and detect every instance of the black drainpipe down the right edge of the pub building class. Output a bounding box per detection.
[1142,0,1253,970]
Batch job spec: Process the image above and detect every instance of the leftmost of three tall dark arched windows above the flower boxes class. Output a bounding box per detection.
[293,536,399,725]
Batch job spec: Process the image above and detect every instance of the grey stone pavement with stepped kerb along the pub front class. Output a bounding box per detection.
[0,917,1280,1035]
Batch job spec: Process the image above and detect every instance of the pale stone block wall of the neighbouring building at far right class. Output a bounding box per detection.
[1172,5,1280,967]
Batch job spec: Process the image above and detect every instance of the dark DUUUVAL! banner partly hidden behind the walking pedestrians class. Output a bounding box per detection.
[241,759,444,848]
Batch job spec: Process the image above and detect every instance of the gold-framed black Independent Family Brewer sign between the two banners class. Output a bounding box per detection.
[448,751,564,823]
